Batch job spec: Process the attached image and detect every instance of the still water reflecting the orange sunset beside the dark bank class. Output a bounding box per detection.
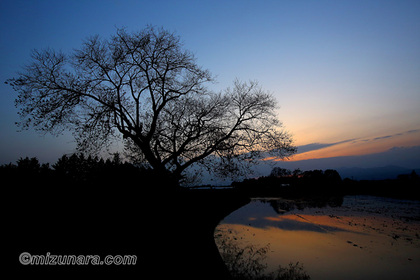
[216,196,420,280]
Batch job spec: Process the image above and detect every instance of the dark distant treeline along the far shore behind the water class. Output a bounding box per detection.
[232,167,420,200]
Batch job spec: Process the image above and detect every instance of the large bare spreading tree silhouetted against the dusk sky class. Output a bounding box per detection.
[7,27,295,184]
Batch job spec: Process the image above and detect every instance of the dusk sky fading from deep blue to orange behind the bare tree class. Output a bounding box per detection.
[0,0,420,164]
